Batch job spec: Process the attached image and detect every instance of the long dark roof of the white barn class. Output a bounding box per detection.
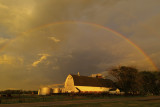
[71,75,113,87]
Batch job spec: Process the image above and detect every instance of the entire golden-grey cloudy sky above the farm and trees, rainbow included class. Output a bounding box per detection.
[0,0,160,90]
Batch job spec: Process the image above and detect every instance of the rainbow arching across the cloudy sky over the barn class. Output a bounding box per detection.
[0,21,158,71]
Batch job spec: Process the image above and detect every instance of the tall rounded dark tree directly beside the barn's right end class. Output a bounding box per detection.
[109,66,138,94]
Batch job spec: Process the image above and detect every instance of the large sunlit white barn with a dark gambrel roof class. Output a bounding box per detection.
[64,74,113,93]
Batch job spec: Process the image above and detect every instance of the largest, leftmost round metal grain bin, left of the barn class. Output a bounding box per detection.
[38,87,53,95]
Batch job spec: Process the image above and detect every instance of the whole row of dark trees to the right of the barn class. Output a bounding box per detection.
[109,66,160,95]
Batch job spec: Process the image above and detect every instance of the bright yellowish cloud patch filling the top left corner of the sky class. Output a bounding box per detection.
[0,0,34,37]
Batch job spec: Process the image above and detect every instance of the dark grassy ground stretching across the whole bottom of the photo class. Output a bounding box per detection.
[1,95,160,107]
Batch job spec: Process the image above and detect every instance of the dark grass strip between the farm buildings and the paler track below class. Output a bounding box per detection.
[0,94,140,104]
